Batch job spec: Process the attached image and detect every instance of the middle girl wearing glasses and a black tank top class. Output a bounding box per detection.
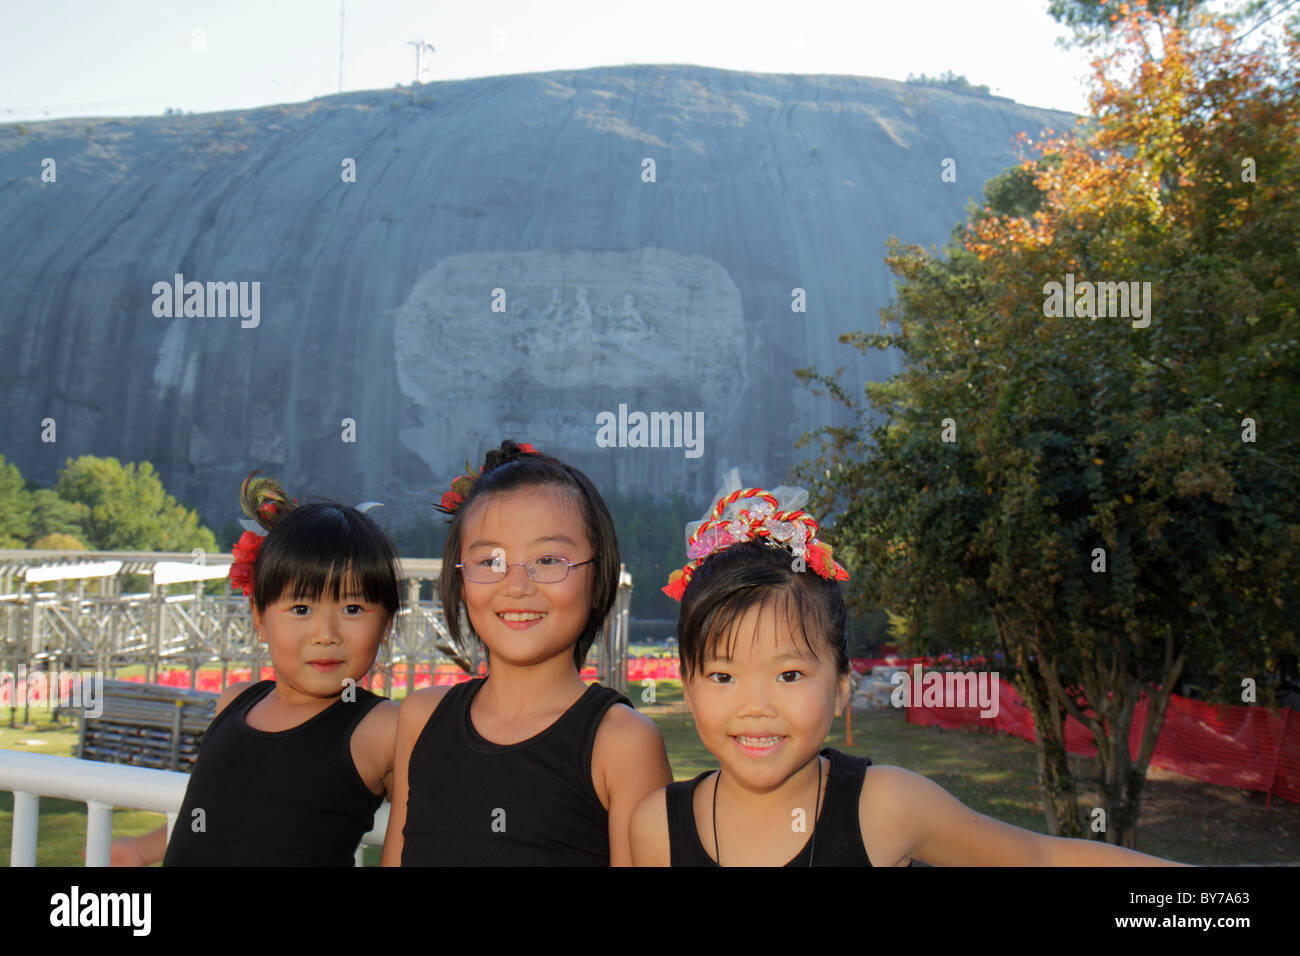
[382,441,672,866]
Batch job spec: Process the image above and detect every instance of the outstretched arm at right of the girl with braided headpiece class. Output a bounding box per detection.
[858,766,1184,866]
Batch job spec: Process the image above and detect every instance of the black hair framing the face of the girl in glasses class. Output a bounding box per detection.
[438,440,620,670]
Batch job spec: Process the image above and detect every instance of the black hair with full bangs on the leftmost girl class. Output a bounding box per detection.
[241,472,402,620]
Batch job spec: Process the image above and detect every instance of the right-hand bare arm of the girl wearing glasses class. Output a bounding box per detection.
[592,704,672,866]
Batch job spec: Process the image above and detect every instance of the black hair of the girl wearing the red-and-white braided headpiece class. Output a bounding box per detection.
[677,541,849,680]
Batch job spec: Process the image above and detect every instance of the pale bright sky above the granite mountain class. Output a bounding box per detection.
[0,0,1107,122]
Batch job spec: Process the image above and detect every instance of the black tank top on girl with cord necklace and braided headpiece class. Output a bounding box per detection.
[667,748,871,866]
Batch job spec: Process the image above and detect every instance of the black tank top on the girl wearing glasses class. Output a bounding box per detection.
[402,678,632,866]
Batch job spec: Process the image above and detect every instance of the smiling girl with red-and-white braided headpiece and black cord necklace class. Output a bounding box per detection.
[631,486,1190,866]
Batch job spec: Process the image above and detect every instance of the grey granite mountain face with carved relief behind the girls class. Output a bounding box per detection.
[0,66,1073,527]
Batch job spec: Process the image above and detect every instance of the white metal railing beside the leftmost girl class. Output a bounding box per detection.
[0,750,389,866]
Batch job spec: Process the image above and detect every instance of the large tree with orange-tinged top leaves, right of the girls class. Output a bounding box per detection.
[800,10,1300,847]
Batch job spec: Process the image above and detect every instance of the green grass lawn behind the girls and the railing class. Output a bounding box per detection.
[0,680,1300,866]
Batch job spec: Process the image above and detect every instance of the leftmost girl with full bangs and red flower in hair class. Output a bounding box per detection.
[112,472,399,866]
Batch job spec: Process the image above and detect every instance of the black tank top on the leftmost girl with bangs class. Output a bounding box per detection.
[163,680,385,866]
